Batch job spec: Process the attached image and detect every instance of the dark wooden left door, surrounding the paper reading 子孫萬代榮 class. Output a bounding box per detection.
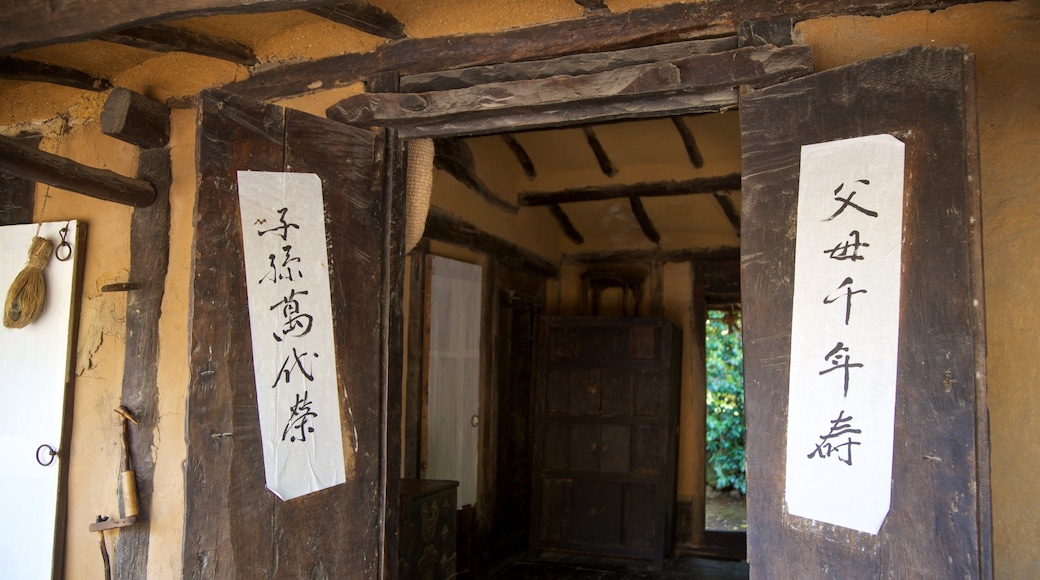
[183,93,399,578]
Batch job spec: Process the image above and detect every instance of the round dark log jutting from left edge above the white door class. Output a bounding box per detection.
[0,136,155,208]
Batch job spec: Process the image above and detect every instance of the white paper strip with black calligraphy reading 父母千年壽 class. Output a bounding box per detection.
[785,135,904,534]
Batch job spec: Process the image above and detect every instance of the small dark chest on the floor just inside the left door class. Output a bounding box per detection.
[398,479,459,580]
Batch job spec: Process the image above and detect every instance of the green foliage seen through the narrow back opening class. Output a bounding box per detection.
[705,310,748,494]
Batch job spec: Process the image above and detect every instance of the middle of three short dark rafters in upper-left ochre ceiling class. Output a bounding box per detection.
[98,24,257,67]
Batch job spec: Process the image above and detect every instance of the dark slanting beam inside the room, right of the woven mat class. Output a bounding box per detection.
[425,206,560,278]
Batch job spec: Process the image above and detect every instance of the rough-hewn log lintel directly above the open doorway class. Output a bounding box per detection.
[327,46,812,127]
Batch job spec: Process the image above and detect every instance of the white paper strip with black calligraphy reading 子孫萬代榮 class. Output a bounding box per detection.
[238,172,346,500]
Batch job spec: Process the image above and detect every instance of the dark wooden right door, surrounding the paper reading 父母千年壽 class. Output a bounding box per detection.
[740,48,991,578]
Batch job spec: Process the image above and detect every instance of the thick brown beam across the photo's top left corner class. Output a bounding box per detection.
[0,0,342,54]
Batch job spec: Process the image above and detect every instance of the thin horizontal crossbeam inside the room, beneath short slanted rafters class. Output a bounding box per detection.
[518,174,740,207]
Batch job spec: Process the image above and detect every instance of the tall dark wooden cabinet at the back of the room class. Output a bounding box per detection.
[531,317,682,568]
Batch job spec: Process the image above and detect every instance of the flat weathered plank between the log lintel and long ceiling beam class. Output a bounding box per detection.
[400,36,736,93]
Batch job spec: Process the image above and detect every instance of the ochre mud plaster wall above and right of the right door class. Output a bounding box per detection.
[798,2,1040,578]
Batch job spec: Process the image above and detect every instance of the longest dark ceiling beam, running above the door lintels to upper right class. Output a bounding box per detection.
[223,0,973,99]
